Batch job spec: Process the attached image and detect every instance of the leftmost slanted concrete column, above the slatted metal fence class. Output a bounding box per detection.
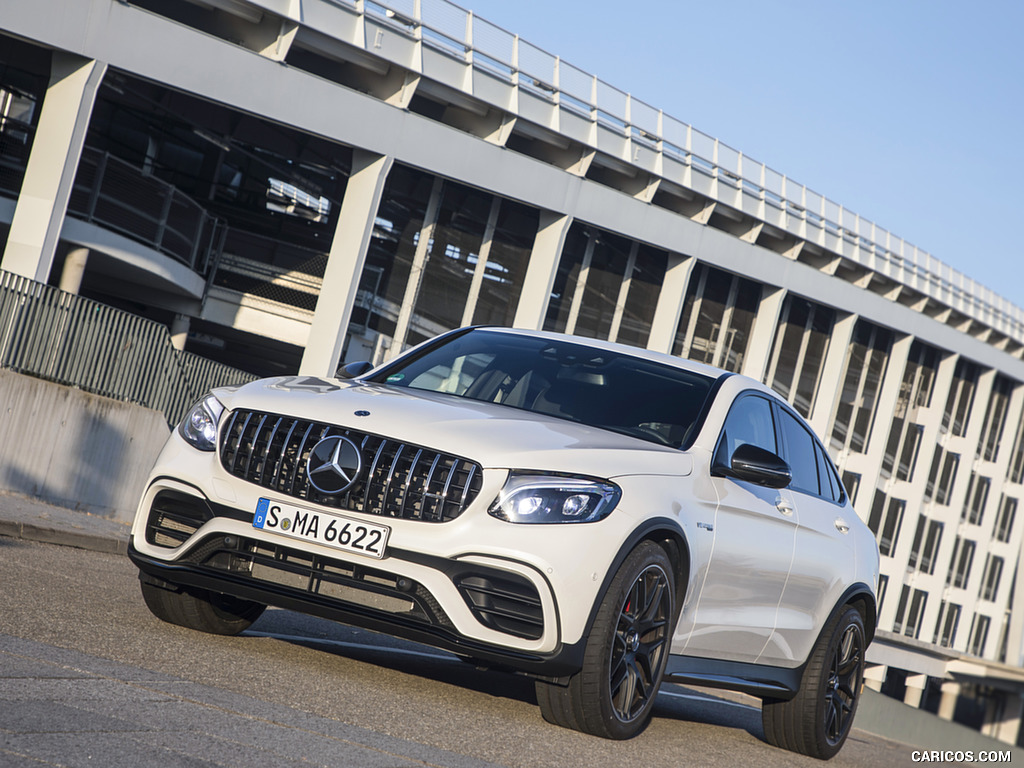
[0,51,106,283]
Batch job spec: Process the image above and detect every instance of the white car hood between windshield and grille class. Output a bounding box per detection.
[215,376,692,477]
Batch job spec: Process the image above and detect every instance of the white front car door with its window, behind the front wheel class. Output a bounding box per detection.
[674,393,798,662]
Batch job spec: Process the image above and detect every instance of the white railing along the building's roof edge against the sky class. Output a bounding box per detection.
[305,0,1024,342]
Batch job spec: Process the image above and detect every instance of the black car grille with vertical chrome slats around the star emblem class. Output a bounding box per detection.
[220,410,482,522]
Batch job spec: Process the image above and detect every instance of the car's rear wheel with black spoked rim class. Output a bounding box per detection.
[761,605,867,760]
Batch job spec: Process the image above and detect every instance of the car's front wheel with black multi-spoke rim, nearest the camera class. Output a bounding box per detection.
[535,542,676,739]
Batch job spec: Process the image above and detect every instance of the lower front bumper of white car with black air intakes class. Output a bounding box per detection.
[129,476,606,677]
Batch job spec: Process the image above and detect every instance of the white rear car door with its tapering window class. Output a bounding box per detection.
[759,406,856,666]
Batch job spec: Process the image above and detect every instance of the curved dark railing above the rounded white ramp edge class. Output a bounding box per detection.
[68,146,223,274]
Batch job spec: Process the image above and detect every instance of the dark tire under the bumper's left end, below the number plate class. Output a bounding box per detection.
[139,581,266,635]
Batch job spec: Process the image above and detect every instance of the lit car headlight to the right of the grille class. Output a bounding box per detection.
[487,472,622,523]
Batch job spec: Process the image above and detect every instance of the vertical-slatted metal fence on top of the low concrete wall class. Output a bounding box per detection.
[0,271,256,425]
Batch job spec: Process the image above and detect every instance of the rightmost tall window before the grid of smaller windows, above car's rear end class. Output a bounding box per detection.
[829,321,892,456]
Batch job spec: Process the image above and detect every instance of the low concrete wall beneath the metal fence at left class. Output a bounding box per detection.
[0,370,170,522]
